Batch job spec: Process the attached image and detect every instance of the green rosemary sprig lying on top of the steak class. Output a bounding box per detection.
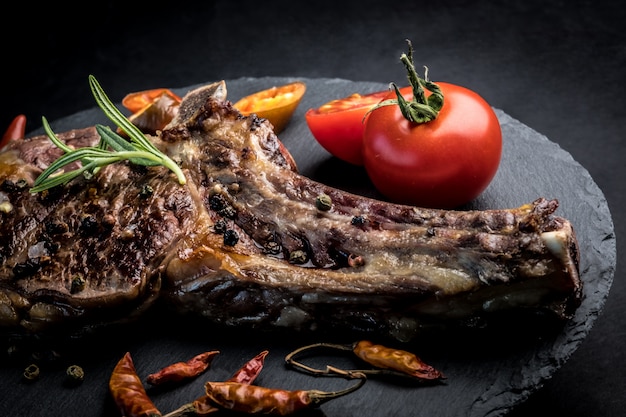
[30,75,187,193]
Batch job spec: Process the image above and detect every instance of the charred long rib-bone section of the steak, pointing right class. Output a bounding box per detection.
[158,92,581,338]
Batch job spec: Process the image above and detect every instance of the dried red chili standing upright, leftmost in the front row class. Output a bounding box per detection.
[109,352,162,417]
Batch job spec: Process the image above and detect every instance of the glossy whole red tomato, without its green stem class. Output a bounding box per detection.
[363,83,502,208]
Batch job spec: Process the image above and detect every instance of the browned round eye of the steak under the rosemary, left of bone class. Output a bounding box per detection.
[0,128,195,330]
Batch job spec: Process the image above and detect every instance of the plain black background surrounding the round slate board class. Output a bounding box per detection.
[0,0,626,417]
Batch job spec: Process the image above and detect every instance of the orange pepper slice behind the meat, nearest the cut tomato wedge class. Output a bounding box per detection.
[234,81,306,134]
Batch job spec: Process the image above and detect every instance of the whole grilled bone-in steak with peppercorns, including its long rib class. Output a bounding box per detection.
[0,83,582,340]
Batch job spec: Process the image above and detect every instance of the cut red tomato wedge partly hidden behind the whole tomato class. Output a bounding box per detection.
[305,88,411,165]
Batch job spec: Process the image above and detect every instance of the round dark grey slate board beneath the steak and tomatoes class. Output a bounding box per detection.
[0,77,616,417]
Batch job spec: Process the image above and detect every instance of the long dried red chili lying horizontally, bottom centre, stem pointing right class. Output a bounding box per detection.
[205,368,366,416]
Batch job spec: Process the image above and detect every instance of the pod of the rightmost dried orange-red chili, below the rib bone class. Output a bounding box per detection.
[352,340,443,379]
